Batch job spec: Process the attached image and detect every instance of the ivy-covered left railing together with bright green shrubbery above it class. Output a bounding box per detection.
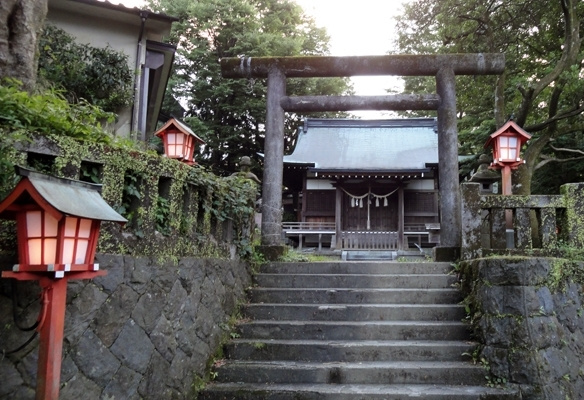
[0,81,257,258]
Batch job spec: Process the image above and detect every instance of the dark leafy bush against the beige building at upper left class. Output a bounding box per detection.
[39,24,133,112]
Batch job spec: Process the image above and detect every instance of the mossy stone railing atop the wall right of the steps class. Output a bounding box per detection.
[461,183,584,260]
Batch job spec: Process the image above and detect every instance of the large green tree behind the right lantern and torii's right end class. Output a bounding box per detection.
[396,0,584,194]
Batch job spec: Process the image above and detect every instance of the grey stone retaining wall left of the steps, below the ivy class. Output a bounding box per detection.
[0,255,251,400]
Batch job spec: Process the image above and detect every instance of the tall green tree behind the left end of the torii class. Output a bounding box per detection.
[150,0,350,175]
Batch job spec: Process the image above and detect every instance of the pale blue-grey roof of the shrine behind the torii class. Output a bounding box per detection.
[284,118,438,171]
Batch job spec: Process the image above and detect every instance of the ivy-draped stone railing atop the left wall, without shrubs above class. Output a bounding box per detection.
[3,136,257,259]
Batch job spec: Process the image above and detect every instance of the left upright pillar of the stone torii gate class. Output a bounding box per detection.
[262,64,286,255]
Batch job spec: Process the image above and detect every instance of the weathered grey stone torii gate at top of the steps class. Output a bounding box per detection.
[221,53,505,260]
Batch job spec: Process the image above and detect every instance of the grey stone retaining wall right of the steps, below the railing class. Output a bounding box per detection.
[462,257,584,400]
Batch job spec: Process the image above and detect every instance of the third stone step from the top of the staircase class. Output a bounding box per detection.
[248,287,462,304]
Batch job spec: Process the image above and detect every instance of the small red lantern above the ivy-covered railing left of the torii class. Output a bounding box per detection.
[154,118,205,165]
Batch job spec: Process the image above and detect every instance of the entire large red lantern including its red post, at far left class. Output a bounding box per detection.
[0,168,127,400]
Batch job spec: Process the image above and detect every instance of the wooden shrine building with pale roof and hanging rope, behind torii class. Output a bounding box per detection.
[283,119,439,250]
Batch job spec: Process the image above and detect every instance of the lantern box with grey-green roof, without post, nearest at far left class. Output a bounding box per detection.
[0,169,126,277]
